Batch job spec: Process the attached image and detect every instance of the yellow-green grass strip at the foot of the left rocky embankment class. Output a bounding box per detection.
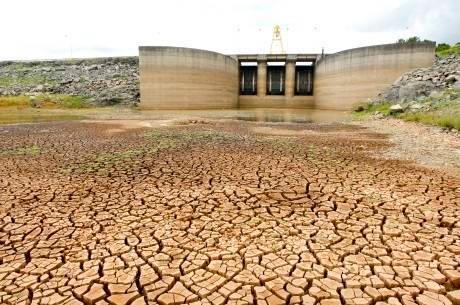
[0,94,90,109]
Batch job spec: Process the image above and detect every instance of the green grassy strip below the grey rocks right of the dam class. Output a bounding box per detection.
[353,89,460,130]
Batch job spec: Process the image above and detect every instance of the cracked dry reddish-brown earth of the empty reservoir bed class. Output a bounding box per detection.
[0,122,460,305]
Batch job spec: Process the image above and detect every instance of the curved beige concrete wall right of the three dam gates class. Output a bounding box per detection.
[314,42,436,110]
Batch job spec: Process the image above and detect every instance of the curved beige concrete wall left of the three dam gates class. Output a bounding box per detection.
[139,47,238,109]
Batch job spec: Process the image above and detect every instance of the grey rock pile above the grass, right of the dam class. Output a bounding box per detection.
[375,55,460,102]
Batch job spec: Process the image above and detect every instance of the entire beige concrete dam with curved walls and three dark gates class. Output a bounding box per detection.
[139,42,436,110]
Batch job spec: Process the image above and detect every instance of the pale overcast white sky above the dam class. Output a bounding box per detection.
[0,0,460,60]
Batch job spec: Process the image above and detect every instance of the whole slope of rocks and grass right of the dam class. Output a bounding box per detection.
[362,55,460,131]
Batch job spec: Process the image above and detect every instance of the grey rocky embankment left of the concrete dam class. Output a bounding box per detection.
[0,57,139,105]
